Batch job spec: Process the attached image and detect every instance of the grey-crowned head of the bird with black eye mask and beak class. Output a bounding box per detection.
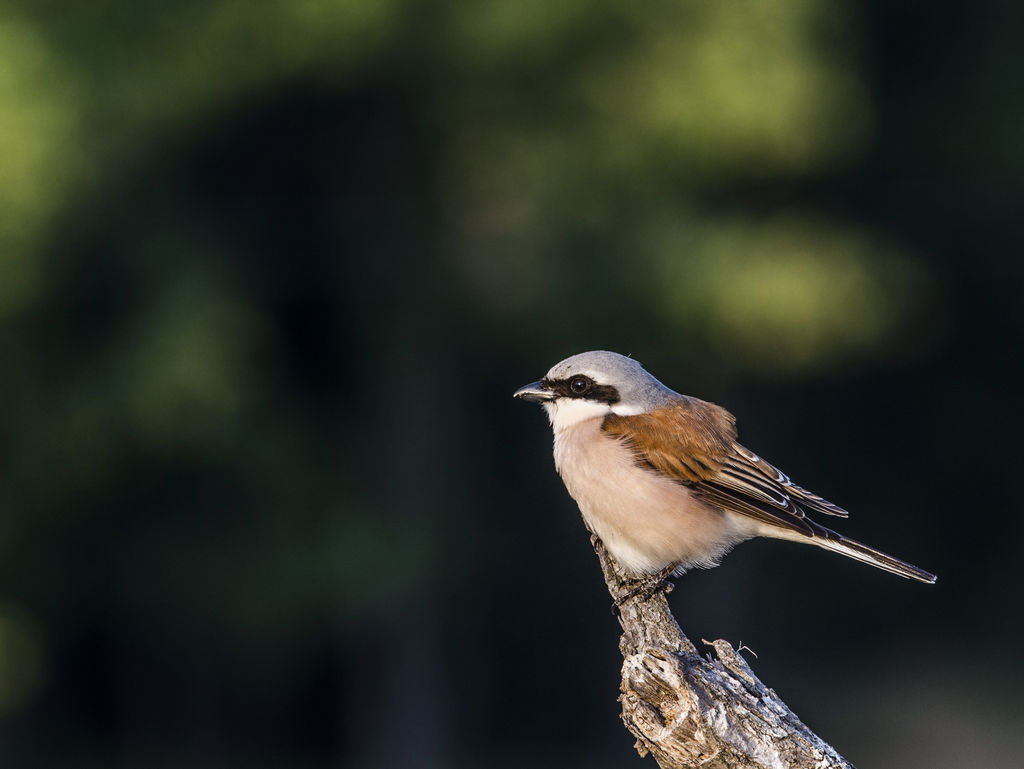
[513,350,679,432]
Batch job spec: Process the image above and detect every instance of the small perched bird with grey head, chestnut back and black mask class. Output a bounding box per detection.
[513,350,937,584]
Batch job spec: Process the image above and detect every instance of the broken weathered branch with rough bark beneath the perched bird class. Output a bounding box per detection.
[593,537,853,769]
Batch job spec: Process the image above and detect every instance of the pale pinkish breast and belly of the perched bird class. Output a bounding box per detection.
[555,419,754,573]
